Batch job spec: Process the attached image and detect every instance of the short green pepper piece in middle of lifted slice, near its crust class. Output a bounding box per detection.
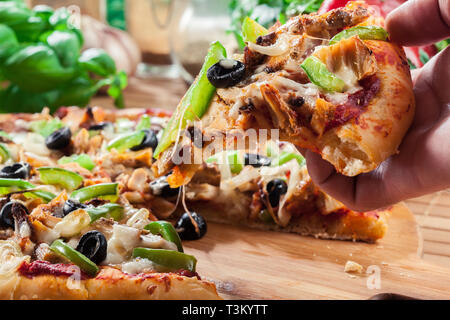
[300,56,345,92]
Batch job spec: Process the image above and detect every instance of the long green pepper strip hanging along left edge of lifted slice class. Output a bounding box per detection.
[154,41,227,158]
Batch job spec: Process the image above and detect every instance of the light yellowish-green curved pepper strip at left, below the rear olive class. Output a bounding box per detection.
[37,167,84,190]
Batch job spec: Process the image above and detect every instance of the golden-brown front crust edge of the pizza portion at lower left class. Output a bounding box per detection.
[0,267,221,300]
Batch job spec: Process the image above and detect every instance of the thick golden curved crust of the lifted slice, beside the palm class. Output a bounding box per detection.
[317,41,415,176]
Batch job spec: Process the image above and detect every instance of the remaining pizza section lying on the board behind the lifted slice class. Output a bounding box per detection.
[51,108,387,242]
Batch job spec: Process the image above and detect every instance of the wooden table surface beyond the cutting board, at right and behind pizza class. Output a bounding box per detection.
[93,78,450,267]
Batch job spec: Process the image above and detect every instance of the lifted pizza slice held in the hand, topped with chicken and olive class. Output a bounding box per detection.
[154,2,415,179]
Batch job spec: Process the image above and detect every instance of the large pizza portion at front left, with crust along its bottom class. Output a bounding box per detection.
[0,109,220,299]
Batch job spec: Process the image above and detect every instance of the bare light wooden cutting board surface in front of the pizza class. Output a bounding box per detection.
[185,204,450,299]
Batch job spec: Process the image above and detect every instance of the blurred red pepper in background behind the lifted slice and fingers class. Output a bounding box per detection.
[318,0,438,68]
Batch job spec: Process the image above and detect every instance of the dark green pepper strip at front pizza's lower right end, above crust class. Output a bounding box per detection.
[133,248,197,272]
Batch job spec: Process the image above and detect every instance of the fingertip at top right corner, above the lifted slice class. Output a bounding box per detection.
[386,0,450,46]
